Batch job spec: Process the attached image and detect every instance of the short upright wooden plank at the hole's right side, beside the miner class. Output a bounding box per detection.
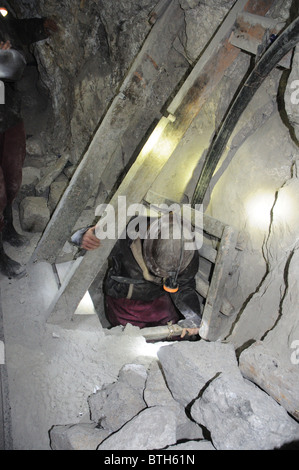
[199,226,237,341]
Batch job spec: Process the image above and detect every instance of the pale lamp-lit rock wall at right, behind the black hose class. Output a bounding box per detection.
[153,2,299,352]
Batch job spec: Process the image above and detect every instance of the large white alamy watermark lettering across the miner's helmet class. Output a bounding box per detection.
[95,196,203,250]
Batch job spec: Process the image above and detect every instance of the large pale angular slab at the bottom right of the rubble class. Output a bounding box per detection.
[191,374,299,450]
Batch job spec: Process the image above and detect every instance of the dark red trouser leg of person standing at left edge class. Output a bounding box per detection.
[1,122,26,246]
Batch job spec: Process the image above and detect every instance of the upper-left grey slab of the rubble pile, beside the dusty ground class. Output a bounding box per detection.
[88,364,147,431]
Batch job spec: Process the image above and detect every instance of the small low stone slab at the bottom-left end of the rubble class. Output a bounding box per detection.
[50,423,109,450]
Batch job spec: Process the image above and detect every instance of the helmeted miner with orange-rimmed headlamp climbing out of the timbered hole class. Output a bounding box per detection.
[72,216,203,336]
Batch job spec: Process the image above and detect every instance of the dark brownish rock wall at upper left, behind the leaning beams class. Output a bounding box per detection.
[12,0,157,162]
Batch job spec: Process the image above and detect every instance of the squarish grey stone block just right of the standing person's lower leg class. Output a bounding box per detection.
[20,196,50,232]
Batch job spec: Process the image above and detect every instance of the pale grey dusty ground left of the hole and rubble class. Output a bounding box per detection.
[0,215,162,450]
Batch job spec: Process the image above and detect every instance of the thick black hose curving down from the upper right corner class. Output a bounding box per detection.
[191,17,299,207]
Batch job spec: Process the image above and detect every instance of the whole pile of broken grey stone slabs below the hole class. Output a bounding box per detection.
[50,340,299,450]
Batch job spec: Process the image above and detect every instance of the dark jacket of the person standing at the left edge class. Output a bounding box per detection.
[0,15,48,132]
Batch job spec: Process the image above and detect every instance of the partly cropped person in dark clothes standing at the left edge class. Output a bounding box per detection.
[0,5,58,277]
